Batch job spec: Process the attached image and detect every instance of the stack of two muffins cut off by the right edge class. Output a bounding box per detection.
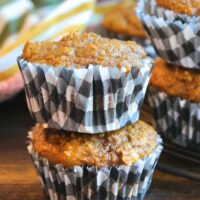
[137,0,200,151]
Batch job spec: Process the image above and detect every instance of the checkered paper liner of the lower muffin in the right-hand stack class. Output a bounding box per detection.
[147,87,200,151]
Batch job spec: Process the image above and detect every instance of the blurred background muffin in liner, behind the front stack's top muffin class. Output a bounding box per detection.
[102,1,156,57]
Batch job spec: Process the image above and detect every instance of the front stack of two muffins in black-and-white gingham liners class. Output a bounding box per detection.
[18,33,162,200]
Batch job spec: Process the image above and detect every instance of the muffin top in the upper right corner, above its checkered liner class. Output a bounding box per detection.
[156,0,200,16]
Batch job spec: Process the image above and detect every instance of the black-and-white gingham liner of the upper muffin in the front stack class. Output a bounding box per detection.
[18,58,153,134]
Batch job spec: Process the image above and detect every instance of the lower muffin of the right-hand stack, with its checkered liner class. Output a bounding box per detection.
[148,58,200,151]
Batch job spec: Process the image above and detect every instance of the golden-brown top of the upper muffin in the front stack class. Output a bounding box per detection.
[22,33,146,71]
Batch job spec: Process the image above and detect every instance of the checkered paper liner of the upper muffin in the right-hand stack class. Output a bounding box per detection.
[136,1,200,69]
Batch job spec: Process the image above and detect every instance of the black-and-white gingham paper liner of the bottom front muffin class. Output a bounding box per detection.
[28,132,163,200]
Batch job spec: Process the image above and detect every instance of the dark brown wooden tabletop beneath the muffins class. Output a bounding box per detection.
[0,93,200,200]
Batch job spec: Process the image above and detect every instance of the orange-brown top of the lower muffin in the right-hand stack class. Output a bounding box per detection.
[150,58,200,103]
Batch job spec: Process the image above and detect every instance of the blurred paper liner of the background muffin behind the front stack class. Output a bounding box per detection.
[104,31,157,58]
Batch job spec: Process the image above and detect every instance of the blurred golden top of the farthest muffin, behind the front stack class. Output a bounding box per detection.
[102,1,146,38]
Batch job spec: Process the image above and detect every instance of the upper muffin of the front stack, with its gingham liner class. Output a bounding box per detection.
[18,33,153,133]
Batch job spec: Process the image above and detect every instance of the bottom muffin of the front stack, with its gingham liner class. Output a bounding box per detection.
[28,121,162,200]
